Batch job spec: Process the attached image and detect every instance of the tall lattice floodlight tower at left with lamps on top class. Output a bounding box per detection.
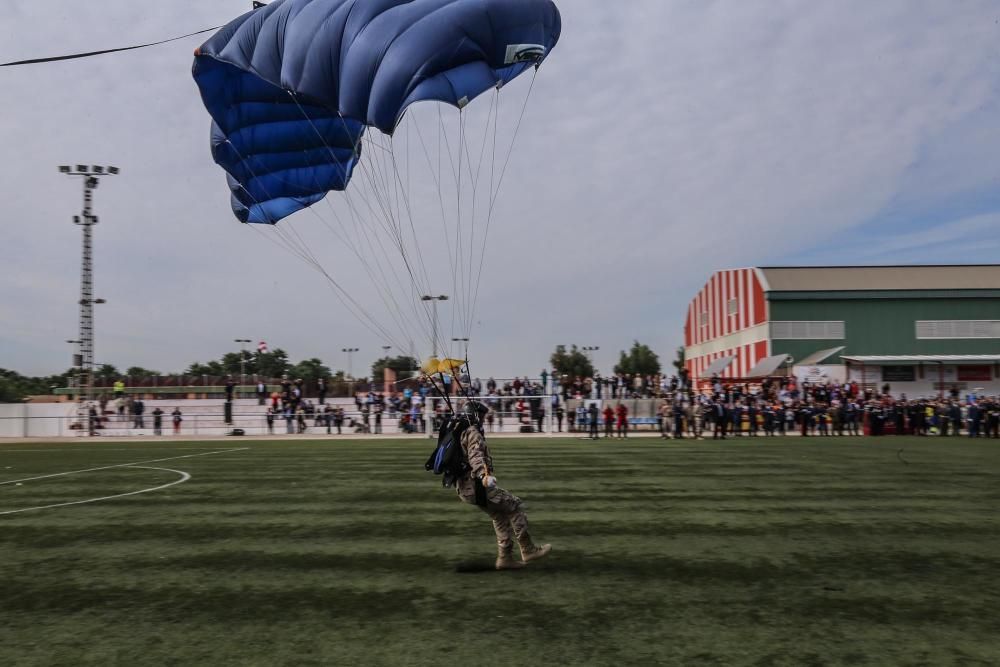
[59,164,119,406]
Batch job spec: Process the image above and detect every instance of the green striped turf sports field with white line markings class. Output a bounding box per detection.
[0,438,1000,666]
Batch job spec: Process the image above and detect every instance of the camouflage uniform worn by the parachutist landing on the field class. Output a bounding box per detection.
[457,427,540,560]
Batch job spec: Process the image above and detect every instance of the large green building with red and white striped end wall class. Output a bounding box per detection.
[684,265,1000,395]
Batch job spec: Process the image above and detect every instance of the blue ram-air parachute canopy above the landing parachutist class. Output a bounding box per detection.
[193,0,561,224]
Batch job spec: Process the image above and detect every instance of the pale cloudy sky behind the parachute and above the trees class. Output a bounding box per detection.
[0,0,1000,377]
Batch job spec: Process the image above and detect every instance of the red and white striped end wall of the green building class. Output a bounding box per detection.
[684,269,771,378]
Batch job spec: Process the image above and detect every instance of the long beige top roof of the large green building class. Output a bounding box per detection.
[759,264,1000,292]
